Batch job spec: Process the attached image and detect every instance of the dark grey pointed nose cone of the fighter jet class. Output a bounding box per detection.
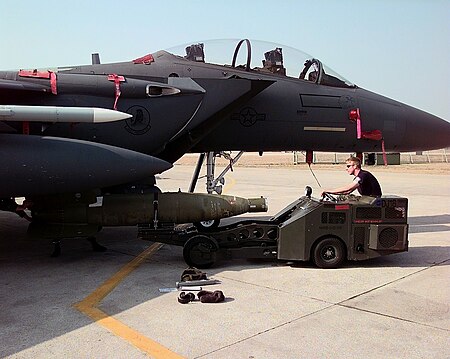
[404,107,450,151]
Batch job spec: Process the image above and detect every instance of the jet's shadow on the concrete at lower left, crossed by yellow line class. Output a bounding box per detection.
[0,218,187,358]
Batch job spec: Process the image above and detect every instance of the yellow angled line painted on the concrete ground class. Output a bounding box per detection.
[73,243,183,359]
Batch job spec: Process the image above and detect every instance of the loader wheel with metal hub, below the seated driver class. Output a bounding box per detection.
[312,237,345,268]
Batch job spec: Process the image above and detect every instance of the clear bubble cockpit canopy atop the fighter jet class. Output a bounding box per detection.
[167,39,356,88]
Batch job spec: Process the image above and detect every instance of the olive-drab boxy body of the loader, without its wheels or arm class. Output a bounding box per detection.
[278,196,408,260]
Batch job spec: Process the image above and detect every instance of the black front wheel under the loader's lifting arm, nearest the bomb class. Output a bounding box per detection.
[183,235,219,268]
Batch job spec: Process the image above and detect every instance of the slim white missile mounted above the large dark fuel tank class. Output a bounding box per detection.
[0,105,132,123]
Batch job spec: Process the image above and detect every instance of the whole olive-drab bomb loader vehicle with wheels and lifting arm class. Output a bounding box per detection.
[138,187,408,268]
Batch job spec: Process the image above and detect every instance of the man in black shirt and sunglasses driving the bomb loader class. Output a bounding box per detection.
[322,157,381,197]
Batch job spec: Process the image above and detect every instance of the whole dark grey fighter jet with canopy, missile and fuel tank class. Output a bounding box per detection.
[0,39,450,242]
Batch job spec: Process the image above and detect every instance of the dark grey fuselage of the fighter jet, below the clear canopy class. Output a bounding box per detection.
[0,46,450,165]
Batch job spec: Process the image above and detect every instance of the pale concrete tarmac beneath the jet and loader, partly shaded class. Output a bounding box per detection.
[0,164,450,359]
